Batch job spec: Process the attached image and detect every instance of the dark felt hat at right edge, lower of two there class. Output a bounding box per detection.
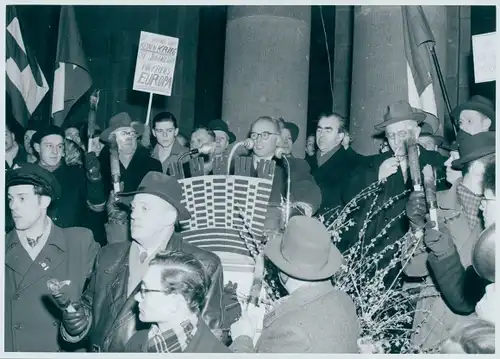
[451,131,495,170]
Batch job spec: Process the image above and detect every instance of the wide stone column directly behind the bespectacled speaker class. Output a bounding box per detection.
[222,6,311,158]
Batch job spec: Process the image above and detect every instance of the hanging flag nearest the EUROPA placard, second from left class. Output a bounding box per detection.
[52,6,92,126]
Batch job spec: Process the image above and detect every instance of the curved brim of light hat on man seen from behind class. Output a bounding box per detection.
[264,234,342,281]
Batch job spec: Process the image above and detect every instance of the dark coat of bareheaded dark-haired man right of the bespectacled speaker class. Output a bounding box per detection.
[310,146,365,213]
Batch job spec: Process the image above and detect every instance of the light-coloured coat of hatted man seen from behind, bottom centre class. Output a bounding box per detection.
[229,281,360,353]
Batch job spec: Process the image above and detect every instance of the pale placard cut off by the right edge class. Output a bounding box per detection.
[472,32,498,83]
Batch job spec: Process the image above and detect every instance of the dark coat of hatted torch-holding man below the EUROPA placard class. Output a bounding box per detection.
[99,145,162,194]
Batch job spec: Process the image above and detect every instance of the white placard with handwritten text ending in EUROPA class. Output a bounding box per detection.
[133,31,179,96]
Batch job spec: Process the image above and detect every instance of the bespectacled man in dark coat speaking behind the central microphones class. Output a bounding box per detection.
[243,116,321,230]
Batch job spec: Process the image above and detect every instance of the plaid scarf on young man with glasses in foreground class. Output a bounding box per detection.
[147,317,198,353]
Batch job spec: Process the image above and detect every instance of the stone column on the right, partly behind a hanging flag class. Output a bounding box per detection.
[350,6,447,155]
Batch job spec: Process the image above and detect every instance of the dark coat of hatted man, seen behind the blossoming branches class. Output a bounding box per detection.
[339,146,446,285]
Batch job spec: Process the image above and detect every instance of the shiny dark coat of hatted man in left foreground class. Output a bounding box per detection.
[61,233,224,352]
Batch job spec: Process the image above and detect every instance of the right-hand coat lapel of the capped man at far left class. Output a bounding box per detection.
[18,223,67,292]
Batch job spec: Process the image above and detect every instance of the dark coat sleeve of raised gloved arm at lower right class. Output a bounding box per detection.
[427,251,490,315]
